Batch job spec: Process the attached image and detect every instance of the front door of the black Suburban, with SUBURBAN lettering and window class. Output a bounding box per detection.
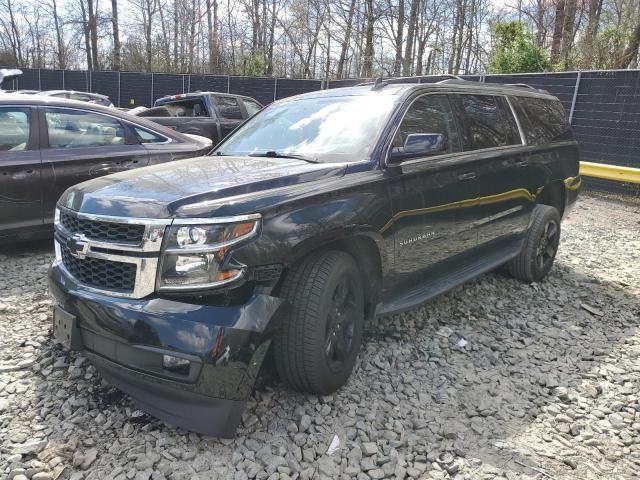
[384,94,477,292]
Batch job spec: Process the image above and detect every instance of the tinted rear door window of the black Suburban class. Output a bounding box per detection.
[452,95,522,151]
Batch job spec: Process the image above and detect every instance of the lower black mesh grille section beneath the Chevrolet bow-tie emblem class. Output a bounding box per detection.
[60,244,136,293]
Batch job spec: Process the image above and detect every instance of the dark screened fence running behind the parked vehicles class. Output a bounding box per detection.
[4,69,640,194]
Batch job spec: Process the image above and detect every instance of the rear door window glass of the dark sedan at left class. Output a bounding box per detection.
[45,108,125,148]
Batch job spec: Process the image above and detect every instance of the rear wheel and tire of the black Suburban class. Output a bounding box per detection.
[508,205,560,283]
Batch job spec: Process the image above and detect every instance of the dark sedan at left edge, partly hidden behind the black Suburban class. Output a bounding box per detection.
[0,94,211,242]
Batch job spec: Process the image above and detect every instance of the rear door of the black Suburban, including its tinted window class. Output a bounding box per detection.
[444,94,535,246]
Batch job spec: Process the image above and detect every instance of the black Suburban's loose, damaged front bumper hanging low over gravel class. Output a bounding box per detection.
[49,263,283,437]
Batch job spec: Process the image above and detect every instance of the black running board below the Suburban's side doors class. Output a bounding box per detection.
[376,240,522,317]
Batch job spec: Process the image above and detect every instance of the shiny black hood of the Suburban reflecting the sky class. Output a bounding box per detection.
[58,156,346,218]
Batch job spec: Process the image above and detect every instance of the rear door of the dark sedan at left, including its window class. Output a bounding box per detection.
[41,107,149,222]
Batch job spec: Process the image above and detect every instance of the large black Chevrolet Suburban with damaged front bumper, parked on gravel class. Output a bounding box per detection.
[49,80,581,436]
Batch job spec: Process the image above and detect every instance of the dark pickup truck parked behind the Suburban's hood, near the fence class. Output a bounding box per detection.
[136,92,262,145]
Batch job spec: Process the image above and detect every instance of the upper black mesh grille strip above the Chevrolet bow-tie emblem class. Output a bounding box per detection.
[60,211,145,245]
